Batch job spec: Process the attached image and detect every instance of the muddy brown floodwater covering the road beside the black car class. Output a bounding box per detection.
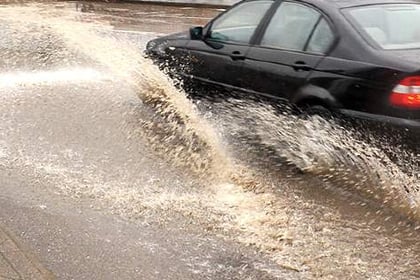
[0,2,420,279]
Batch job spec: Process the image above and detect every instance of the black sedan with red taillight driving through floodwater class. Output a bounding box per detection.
[146,0,420,139]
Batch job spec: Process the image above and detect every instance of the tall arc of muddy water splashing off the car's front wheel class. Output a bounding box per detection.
[44,13,231,179]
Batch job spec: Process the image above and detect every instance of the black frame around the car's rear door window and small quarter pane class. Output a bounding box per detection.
[252,0,340,56]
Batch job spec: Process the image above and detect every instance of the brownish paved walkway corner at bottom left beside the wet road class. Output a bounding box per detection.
[0,225,55,280]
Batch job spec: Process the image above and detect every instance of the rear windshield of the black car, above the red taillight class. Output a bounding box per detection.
[348,4,420,50]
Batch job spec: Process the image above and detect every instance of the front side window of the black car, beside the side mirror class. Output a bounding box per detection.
[208,0,273,43]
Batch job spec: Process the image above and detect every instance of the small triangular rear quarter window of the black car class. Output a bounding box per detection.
[306,18,335,54]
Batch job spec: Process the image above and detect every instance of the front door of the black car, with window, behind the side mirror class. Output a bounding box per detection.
[186,0,274,87]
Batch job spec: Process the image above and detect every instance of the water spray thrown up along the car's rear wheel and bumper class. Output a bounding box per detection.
[210,100,420,219]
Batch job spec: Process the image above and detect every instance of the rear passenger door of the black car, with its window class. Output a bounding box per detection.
[243,1,331,100]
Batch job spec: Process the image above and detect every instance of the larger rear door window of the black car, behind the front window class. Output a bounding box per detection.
[261,2,321,51]
